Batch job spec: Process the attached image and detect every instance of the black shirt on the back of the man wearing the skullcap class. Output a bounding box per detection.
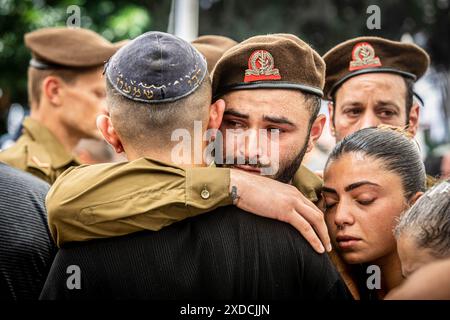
[41,206,351,300]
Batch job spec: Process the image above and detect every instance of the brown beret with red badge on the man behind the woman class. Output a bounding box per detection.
[323,37,430,99]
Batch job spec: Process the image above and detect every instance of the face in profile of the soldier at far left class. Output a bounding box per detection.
[61,68,106,139]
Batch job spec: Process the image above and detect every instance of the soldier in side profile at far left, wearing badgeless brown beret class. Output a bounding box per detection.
[0,28,119,184]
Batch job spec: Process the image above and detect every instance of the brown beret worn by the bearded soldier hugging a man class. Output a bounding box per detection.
[212,34,325,98]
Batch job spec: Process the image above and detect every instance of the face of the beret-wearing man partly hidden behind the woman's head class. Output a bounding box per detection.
[329,73,419,142]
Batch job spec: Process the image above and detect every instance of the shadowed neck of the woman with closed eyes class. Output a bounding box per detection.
[372,250,403,299]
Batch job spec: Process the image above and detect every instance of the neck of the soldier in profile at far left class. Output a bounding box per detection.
[30,108,80,153]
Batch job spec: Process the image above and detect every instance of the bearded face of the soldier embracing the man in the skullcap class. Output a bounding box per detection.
[220,89,322,182]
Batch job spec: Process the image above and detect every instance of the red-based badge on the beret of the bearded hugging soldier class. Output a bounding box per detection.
[244,50,281,82]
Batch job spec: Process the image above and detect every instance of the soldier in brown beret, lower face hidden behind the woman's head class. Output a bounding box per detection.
[323,37,430,141]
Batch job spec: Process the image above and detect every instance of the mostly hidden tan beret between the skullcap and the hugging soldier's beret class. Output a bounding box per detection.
[191,35,238,74]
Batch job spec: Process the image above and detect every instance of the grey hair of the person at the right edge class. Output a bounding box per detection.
[394,180,450,258]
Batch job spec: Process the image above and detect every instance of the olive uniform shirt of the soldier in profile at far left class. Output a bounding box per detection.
[0,117,80,184]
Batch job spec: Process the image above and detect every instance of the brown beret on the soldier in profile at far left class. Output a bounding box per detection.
[25,27,123,69]
